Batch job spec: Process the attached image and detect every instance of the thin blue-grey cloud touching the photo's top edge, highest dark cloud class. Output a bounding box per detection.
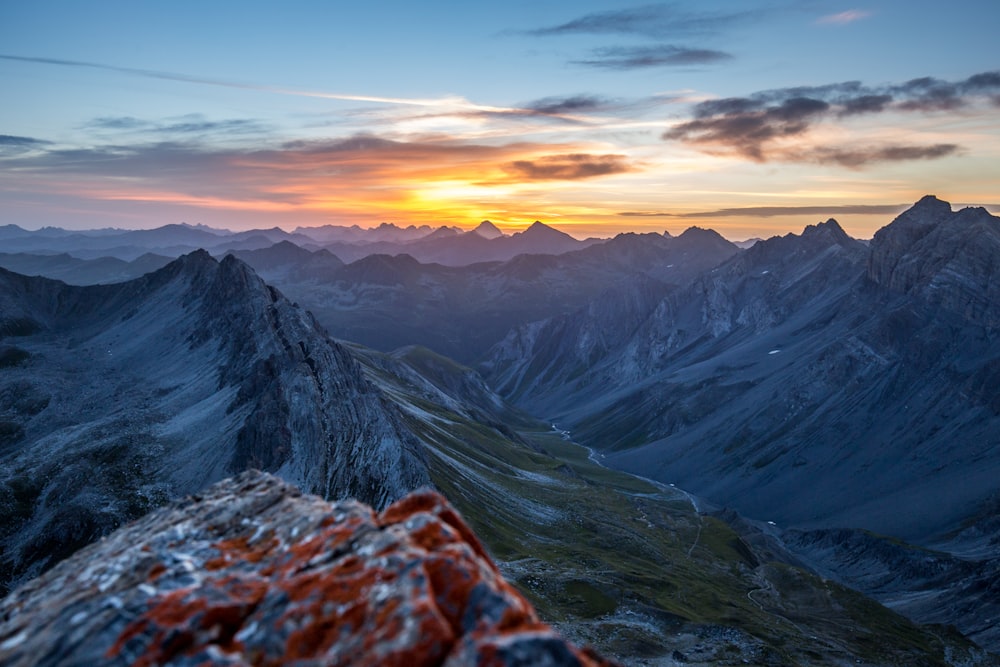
[528,4,763,39]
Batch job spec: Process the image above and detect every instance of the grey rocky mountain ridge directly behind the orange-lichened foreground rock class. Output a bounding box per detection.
[0,252,428,596]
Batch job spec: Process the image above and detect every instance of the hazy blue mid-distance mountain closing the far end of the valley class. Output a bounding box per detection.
[258,229,737,363]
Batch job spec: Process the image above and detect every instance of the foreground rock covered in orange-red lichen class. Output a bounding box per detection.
[0,472,611,667]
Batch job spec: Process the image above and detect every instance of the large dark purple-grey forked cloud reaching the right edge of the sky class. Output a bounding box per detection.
[663,72,1000,168]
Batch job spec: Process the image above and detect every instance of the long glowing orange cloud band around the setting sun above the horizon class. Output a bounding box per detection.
[3,135,639,230]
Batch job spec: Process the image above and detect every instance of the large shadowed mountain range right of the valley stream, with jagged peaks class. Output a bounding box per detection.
[483,198,1000,646]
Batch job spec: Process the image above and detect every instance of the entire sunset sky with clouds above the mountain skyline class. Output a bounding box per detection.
[0,0,1000,239]
